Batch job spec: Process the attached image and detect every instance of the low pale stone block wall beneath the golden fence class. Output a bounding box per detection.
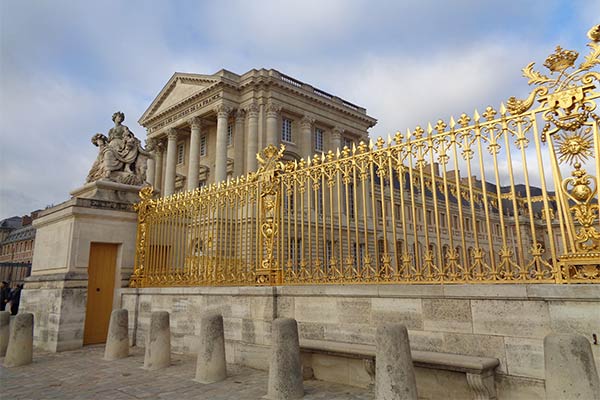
[120,285,600,399]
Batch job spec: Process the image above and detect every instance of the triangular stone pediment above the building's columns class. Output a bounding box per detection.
[139,72,219,125]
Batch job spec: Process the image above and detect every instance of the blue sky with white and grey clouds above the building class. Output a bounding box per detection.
[0,0,600,220]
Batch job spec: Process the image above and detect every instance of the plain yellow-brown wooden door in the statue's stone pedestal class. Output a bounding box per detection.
[83,243,118,345]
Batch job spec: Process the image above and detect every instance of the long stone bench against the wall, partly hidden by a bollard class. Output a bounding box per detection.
[300,339,500,400]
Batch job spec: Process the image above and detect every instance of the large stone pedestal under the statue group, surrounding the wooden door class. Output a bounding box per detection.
[20,181,140,351]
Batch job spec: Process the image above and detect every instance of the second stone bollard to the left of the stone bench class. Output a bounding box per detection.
[195,314,227,383]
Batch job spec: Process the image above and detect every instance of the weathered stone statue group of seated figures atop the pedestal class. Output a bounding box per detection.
[86,111,150,186]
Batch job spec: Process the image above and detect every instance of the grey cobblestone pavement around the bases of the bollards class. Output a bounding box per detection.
[0,346,374,400]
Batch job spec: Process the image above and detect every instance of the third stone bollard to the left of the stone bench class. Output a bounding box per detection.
[144,311,171,370]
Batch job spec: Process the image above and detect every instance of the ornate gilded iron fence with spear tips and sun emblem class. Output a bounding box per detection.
[131,27,600,286]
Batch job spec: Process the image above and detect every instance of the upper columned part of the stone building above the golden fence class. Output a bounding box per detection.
[139,69,377,196]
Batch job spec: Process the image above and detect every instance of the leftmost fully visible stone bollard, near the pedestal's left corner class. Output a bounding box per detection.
[4,313,33,367]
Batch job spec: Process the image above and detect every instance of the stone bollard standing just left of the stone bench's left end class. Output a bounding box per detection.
[267,318,304,400]
